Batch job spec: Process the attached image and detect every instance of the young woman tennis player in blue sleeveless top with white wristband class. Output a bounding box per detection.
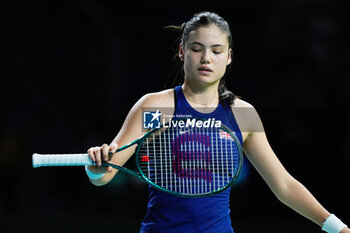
[86,12,350,233]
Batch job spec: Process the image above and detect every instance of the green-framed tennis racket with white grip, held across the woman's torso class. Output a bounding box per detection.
[33,118,243,197]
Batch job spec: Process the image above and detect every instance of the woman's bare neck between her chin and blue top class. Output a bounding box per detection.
[182,80,219,108]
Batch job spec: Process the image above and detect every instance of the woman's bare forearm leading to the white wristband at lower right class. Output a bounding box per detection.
[276,178,330,226]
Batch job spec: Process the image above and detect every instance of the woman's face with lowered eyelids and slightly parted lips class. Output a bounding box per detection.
[179,24,231,87]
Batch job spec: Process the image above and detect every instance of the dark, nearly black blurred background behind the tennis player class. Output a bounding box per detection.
[0,0,350,233]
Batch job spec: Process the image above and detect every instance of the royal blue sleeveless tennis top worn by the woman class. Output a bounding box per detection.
[140,86,243,233]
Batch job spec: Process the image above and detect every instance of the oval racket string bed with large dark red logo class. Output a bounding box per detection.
[138,125,240,195]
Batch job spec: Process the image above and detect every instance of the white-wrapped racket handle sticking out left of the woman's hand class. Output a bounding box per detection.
[32,153,94,168]
